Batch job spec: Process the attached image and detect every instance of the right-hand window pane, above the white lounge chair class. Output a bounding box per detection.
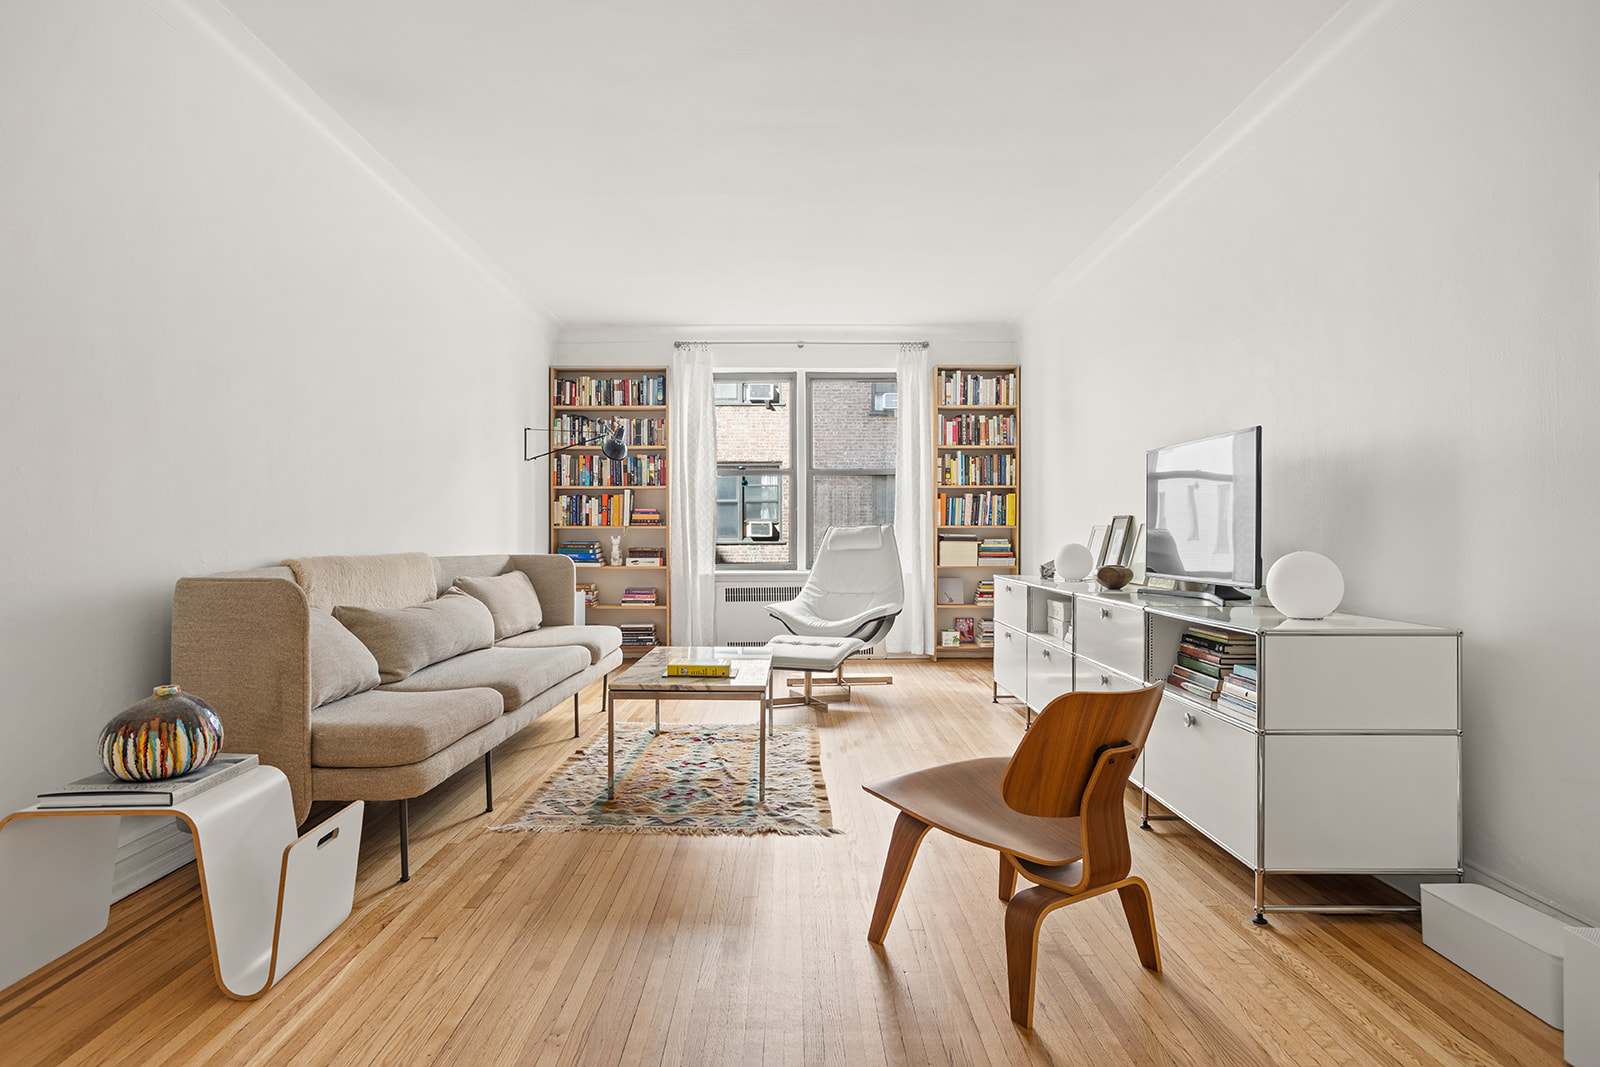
[806,374,899,565]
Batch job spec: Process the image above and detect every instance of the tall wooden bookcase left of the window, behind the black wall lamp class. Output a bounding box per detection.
[549,366,672,657]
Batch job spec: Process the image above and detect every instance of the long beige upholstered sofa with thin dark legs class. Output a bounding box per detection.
[173,553,622,881]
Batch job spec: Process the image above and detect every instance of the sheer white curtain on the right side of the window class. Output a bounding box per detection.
[885,344,933,656]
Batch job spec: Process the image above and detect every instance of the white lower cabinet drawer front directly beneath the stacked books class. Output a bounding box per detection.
[1144,694,1256,865]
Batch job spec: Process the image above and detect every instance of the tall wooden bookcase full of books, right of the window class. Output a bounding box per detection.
[931,366,1022,659]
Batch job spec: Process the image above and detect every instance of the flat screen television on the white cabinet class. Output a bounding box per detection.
[1144,426,1261,597]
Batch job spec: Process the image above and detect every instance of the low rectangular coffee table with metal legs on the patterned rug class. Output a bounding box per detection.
[605,645,773,801]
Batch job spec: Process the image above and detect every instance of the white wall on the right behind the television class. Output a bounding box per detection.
[1021,0,1600,925]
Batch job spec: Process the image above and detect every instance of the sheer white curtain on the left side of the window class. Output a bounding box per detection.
[667,342,717,645]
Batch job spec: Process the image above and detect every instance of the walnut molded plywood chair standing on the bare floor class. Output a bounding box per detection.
[864,685,1162,1027]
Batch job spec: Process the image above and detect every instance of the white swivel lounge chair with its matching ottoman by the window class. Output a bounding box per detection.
[766,526,906,705]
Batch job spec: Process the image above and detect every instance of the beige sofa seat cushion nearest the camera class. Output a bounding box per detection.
[310,689,501,766]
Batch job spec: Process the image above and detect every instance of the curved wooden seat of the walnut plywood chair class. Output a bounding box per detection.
[864,755,1083,867]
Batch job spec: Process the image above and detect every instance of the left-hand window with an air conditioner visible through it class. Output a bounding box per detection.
[712,374,795,568]
